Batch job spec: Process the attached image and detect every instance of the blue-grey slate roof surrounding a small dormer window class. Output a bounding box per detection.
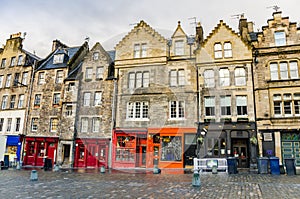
[38,46,80,70]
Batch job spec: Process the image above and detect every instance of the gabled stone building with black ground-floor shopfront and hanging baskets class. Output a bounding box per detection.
[195,20,256,168]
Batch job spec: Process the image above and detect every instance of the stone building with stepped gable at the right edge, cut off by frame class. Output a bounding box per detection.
[247,11,300,166]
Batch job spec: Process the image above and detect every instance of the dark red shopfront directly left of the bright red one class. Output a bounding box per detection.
[74,138,110,168]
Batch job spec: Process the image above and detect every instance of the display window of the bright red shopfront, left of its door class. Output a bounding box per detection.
[116,135,136,162]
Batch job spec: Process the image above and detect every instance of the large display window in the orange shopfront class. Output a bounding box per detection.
[160,136,182,161]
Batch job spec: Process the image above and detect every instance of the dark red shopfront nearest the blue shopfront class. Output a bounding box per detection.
[23,137,58,167]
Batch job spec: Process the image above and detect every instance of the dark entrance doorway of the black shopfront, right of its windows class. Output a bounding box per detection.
[232,139,249,168]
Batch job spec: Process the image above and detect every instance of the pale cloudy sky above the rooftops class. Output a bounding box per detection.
[0,0,300,58]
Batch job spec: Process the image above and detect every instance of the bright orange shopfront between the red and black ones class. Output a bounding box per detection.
[147,128,196,172]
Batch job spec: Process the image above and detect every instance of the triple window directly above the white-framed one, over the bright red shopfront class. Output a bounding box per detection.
[128,71,150,88]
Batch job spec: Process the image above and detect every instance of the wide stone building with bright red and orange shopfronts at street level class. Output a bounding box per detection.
[112,21,197,168]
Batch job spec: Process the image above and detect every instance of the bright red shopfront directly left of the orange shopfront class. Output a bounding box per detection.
[112,129,147,168]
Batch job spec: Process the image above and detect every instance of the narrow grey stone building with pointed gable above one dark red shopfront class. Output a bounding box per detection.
[74,43,115,168]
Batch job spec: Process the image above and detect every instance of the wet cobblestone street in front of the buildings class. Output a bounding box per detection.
[0,169,300,199]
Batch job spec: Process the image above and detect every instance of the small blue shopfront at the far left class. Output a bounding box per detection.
[4,135,22,166]
